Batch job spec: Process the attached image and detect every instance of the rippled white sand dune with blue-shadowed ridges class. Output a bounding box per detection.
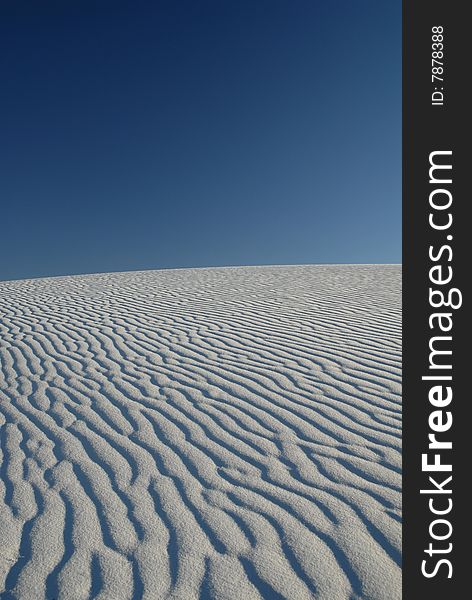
[0,265,401,600]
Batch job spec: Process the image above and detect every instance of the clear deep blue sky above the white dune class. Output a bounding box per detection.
[0,0,401,279]
